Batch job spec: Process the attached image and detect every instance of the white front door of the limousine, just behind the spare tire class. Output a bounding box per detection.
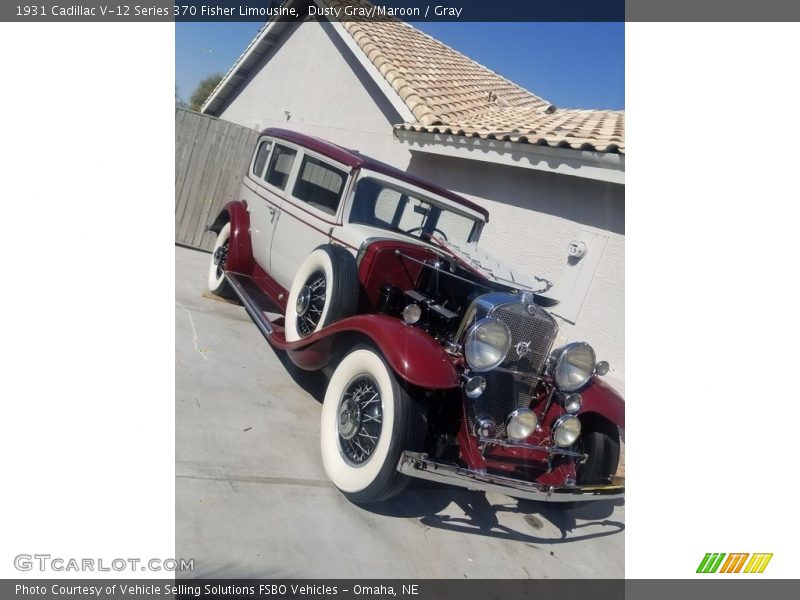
[271,152,350,289]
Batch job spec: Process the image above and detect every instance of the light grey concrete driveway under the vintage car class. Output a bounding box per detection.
[175,247,625,578]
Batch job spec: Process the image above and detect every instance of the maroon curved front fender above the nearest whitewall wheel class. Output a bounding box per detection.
[282,314,459,389]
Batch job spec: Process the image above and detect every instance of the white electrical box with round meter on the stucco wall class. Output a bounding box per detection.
[550,229,608,323]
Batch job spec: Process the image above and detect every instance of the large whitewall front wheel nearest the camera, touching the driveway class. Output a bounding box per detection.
[320,346,425,504]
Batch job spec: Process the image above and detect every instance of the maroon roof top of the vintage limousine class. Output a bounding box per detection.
[261,127,489,221]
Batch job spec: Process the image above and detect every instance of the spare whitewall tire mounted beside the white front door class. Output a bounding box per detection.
[285,244,359,342]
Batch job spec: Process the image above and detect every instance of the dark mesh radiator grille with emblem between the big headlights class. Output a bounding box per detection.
[467,303,558,437]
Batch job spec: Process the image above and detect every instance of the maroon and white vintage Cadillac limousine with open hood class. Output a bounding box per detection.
[208,129,624,503]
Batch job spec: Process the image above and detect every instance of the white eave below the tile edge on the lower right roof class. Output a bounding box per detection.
[394,128,625,185]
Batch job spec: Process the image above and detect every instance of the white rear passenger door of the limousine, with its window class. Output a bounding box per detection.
[242,138,297,273]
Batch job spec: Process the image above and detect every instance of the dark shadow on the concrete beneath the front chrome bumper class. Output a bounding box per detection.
[362,480,625,545]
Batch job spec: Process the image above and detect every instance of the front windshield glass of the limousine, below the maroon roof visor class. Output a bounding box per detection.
[350,178,479,244]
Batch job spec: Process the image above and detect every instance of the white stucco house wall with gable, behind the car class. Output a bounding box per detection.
[214,23,625,390]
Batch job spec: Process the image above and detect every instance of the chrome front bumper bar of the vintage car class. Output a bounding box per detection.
[397,451,625,502]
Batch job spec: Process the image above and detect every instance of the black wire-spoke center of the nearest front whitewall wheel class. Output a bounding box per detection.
[337,376,383,466]
